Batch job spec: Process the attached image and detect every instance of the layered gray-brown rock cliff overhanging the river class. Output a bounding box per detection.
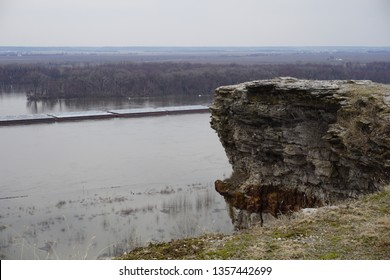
[210,78,390,224]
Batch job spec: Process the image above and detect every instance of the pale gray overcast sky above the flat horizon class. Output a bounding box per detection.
[0,0,390,46]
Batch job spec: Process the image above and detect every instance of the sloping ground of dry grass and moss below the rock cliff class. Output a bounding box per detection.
[118,186,390,260]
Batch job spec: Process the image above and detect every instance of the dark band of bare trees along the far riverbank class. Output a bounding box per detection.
[0,62,390,100]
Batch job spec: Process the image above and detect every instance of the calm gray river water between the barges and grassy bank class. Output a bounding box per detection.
[0,93,233,259]
